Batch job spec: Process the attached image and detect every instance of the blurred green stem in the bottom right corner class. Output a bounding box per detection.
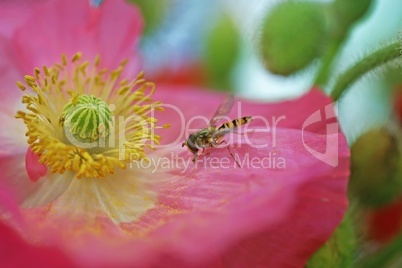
[355,232,402,268]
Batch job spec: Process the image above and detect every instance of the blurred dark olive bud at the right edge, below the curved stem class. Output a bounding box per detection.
[349,129,402,207]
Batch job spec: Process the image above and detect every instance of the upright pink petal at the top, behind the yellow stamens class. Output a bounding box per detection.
[14,0,142,74]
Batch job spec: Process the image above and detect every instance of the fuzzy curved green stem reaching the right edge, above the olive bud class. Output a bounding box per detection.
[331,41,401,101]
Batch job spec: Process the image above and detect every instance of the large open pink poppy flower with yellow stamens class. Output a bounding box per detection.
[0,0,349,267]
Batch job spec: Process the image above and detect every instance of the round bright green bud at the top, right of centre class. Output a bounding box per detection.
[260,1,327,76]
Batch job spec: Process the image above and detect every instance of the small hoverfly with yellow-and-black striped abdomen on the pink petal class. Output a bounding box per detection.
[182,95,252,167]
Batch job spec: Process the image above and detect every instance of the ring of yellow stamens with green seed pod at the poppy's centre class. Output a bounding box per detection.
[16,53,168,178]
